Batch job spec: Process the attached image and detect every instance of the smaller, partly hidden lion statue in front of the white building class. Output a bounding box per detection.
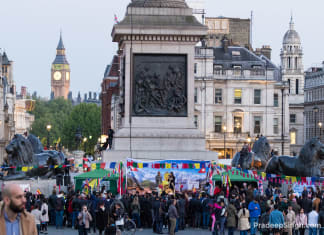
[232,136,271,170]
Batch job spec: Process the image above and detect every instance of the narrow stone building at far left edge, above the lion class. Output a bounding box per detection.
[0,52,16,164]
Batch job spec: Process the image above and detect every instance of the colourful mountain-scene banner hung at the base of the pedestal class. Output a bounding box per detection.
[127,159,210,192]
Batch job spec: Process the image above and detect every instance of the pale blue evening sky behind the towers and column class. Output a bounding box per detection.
[0,0,324,97]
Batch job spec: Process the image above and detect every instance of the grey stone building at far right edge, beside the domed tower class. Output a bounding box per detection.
[305,62,324,141]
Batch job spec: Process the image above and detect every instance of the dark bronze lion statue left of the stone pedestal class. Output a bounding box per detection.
[4,134,65,180]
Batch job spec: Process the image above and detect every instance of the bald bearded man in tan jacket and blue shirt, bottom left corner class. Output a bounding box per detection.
[0,184,37,235]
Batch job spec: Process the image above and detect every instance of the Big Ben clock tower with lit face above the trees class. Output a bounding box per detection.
[51,34,70,99]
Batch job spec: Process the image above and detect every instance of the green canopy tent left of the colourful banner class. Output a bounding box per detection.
[74,169,118,194]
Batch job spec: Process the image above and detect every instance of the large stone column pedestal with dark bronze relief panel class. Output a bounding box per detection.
[103,0,217,161]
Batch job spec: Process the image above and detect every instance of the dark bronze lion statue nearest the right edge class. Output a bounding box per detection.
[265,138,324,177]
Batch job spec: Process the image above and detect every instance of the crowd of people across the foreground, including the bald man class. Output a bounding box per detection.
[0,183,324,235]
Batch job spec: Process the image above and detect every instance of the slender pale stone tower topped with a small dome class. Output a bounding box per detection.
[280,17,305,155]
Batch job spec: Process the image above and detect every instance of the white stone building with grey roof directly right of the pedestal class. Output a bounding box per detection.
[194,38,290,159]
